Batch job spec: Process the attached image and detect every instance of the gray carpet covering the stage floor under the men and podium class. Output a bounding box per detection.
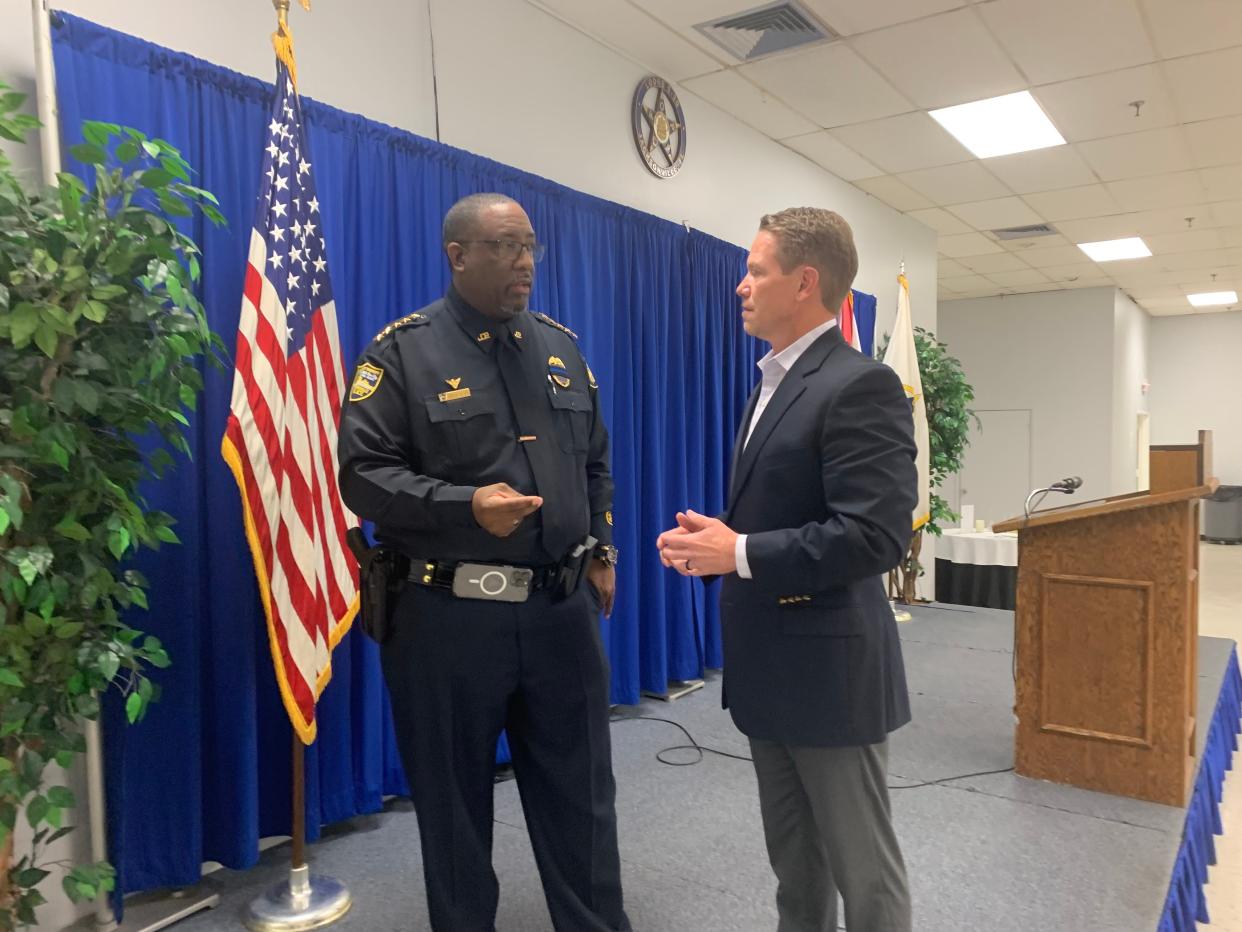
[142,606,1233,932]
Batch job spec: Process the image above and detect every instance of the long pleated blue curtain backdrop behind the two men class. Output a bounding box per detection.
[55,14,874,892]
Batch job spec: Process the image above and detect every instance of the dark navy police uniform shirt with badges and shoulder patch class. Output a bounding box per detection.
[338,288,612,565]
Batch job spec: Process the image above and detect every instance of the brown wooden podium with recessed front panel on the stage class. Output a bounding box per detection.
[994,431,1216,806]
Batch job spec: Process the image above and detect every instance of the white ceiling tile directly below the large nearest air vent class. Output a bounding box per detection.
[738,42,914,127]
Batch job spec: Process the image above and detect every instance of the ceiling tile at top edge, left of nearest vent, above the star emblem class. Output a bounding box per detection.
[540,0,720,81]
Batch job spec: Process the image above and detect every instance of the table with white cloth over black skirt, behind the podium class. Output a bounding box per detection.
[935,528,1017,610]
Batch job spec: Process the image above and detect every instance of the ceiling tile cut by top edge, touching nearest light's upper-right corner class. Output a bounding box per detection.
[975,0,1155,85]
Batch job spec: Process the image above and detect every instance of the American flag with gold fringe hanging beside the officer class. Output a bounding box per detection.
[221,63,358,744]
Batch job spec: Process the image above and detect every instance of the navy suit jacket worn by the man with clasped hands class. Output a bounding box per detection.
[720,327,917,746]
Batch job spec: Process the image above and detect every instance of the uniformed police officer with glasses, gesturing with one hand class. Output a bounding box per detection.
[339,194,630,932]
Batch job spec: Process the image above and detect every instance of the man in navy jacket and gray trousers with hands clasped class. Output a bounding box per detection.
[658,208,917,932]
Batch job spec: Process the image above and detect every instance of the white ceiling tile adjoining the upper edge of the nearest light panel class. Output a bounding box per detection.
[848,10,1026,108]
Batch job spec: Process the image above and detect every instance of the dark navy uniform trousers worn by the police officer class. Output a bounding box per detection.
[383,584,630,932]
